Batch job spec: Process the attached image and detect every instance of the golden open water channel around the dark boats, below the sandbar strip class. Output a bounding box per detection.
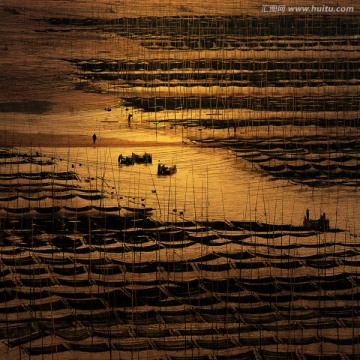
[4,141,359,233]
